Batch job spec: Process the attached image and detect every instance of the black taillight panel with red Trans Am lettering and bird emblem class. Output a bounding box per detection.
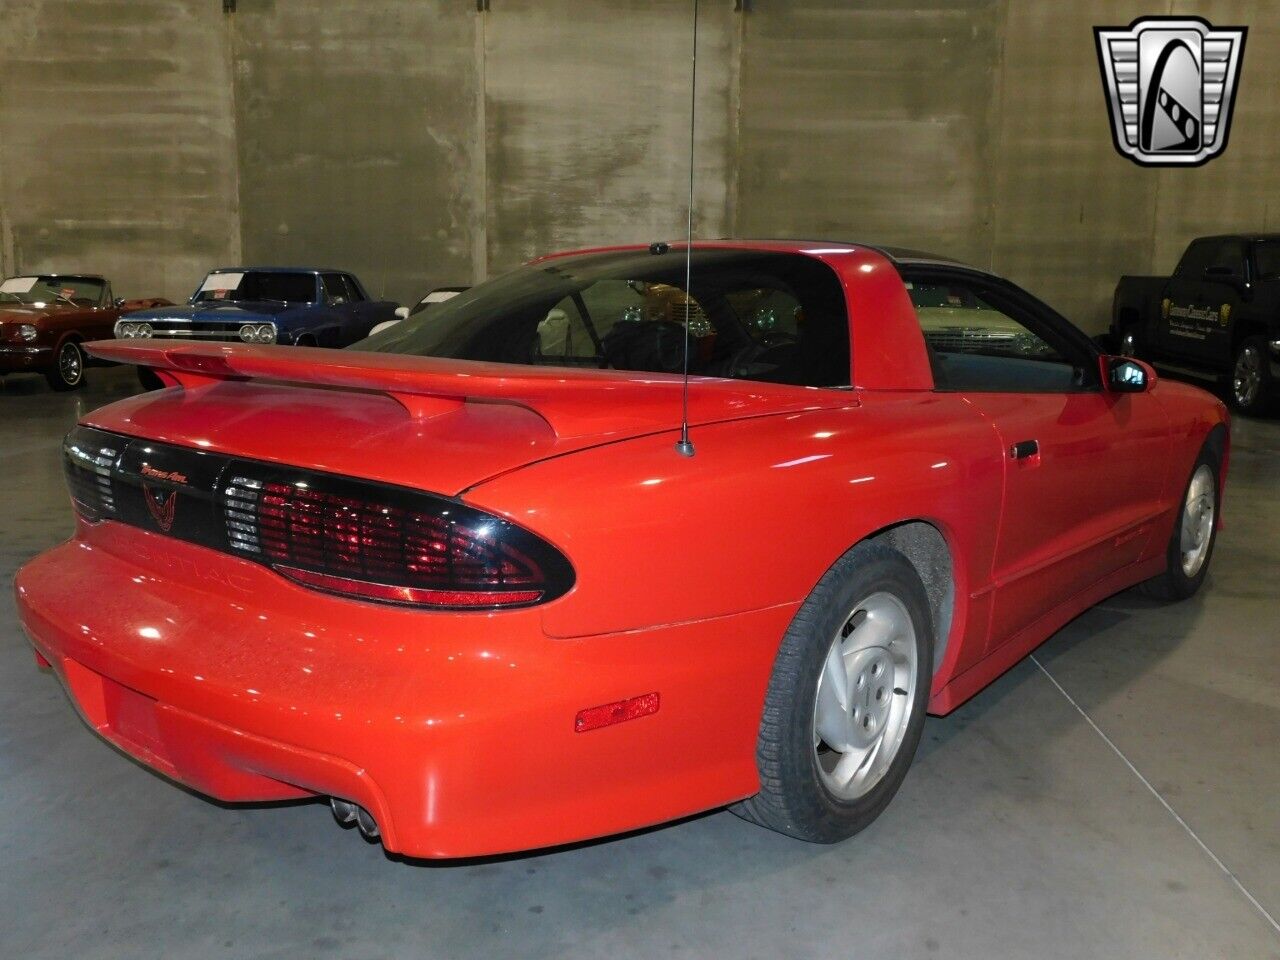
[64,428,573,609]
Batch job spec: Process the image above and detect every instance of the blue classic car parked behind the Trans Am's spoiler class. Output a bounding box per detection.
[115,266,399,347]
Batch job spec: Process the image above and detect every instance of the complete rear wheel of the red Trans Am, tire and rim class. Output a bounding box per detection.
[732,543,933,844]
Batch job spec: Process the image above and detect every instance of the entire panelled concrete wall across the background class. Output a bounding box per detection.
[0,0,1280,330]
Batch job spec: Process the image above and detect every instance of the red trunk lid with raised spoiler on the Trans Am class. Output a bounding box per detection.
[83,340,858,495]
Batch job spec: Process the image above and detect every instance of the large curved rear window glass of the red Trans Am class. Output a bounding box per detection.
[353,250,849,387]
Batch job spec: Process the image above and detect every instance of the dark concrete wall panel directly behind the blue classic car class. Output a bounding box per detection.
[231,0,483,300]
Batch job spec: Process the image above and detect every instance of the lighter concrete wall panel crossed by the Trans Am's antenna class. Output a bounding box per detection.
[483,0,735,270]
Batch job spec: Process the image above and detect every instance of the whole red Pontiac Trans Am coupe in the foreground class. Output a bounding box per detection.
[17,241,1229,858]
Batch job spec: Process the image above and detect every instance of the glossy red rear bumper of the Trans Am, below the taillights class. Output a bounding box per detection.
[15,522,794,858]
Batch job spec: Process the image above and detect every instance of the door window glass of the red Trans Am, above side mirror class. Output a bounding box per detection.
[906,280,1087,393]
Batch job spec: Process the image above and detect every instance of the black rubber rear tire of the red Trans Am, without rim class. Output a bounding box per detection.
[731,543,933,844]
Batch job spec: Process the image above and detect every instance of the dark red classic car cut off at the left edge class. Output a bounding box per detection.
[0,274,170,390]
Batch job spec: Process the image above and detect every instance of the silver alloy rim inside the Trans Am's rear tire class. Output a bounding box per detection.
[813,593,919,800]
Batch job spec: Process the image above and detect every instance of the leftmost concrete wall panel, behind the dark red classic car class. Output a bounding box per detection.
[0,0,239,300]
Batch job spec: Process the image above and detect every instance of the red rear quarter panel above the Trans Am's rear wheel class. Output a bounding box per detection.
[463,392,1002,686]
